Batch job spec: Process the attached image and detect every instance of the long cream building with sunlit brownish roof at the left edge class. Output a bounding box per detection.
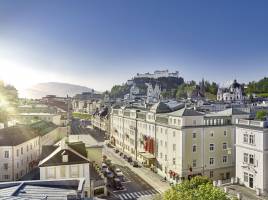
[0,121,67,181]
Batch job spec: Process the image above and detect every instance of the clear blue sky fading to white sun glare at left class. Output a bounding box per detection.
[0,0,268,94]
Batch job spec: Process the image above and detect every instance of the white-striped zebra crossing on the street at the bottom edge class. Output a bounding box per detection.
[117,190,158,200]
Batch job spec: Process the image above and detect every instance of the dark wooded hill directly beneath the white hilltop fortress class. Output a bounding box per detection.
[110,77,184,98]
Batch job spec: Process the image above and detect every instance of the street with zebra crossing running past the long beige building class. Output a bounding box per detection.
[71,119,158,200]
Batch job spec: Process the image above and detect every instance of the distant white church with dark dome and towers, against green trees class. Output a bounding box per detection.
[217,80,244,102]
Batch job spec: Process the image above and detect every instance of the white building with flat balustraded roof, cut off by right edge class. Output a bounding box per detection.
[236,119,268,194]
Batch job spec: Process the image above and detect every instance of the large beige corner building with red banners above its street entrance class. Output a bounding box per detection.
[111,102,248,182]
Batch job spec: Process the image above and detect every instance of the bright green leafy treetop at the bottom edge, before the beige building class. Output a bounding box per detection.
[164,176,229,200]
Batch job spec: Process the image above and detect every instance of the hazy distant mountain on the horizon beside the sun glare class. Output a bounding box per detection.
[19,82,97,99]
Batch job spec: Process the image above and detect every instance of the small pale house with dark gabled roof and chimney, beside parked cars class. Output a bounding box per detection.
[39,141,107,197]
